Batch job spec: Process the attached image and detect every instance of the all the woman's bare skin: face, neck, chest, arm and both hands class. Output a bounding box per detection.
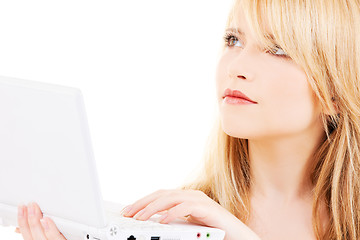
[17,6,334,240]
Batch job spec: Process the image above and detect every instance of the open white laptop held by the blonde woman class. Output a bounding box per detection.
[0,76,225,240]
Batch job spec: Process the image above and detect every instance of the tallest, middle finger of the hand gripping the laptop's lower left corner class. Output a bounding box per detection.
[28,202,46,240]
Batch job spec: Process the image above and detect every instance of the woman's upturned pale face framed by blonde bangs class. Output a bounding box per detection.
[216,7,322,139]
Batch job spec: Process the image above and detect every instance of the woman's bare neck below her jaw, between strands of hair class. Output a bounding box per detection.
[248,125,324,203]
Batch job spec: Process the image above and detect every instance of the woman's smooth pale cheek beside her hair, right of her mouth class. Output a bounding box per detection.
[261,69,319,132]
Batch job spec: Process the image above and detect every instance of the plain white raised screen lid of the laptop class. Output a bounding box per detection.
[0,76,107,228]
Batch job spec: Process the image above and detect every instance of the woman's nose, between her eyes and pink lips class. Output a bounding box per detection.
[228,48,256,81]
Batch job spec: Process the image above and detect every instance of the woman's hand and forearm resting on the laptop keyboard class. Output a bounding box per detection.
[122,190,260,240]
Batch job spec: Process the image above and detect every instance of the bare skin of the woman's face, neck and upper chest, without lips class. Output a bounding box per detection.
[216,7,327,240]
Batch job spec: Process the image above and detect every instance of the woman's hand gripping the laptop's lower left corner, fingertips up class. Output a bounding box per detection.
[15,203,66,240]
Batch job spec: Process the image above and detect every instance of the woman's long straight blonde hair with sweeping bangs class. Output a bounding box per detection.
[183,0,360,240]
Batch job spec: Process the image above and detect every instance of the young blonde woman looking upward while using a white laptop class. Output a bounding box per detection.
[14,0,360,240]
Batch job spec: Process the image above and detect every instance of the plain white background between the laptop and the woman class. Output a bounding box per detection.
[0,0,231,240]
